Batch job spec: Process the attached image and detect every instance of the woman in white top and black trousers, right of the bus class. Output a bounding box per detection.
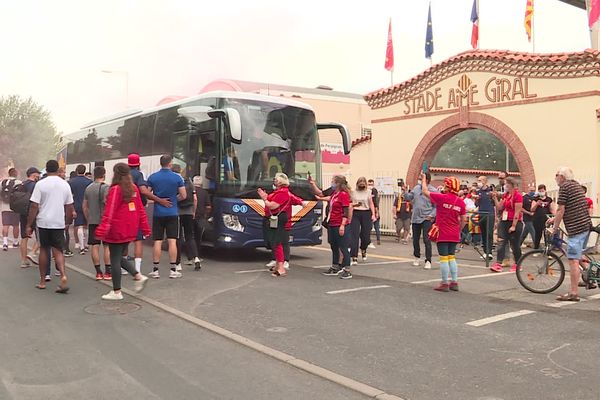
[350,177,377,265]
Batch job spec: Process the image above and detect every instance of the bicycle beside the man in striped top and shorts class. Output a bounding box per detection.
[516,225,600,294]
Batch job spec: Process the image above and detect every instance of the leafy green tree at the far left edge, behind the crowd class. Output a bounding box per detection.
[0,95,59,175]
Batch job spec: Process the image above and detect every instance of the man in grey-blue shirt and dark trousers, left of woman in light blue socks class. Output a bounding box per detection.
[405,172,438,269]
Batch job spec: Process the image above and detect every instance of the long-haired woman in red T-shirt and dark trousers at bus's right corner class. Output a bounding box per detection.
[317,175,352,279]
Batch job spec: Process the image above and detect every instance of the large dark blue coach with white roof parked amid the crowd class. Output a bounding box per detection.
[60,91,351,248]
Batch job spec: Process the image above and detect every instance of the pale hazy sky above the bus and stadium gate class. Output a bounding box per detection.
[0,0,590,133]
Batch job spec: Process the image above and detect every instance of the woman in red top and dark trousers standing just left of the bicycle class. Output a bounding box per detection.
[490,177,523,272]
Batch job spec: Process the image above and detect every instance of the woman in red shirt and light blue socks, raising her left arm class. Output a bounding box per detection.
[421,174,467,292]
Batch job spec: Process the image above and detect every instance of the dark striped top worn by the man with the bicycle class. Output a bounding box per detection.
[557,180,592,236]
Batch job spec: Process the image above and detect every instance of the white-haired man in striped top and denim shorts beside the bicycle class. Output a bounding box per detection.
[552,167,592,301]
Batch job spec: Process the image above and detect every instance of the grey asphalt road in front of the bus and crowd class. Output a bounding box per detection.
[0,234,600,400]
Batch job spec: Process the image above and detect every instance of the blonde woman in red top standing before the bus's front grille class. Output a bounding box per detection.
[258,172,292,277]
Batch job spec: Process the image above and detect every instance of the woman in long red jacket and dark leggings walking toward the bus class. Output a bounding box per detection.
[96,163,151,300]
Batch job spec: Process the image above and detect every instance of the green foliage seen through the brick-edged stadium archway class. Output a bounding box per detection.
[431,129,519,172]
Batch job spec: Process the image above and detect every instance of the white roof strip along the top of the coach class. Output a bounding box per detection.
[81,91,314,129]
